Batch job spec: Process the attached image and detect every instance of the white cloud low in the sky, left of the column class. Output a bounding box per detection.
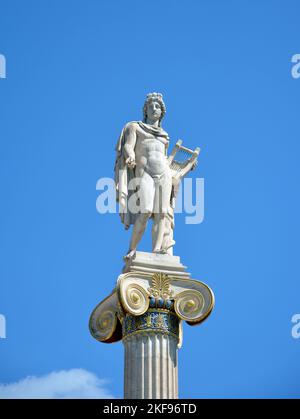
[0,369,114,399]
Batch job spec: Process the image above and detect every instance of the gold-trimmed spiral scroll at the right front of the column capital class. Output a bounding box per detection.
[174,290,205,322]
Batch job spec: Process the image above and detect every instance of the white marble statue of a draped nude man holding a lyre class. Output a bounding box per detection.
[115,92,200,260]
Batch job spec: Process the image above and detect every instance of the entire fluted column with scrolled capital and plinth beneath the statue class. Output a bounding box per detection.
[90,252,214,399]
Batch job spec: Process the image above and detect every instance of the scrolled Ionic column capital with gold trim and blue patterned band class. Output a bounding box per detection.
[89,255,215,343]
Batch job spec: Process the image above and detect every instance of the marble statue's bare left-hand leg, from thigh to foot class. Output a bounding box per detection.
[125,172,155,259]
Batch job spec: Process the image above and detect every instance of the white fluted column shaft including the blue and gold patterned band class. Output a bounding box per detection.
[123,310,179,399]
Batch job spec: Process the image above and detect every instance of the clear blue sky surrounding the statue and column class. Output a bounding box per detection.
[0,0,300,397]
